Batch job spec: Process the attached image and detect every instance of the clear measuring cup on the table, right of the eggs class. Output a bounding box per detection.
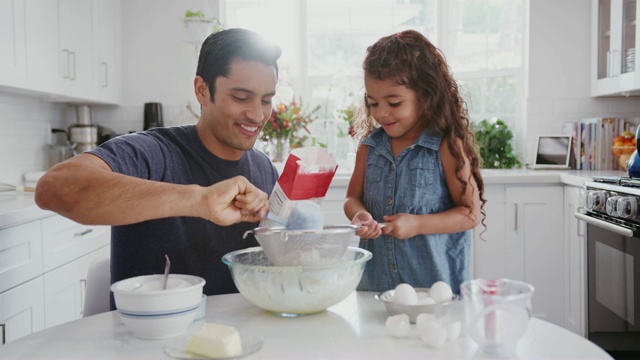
[460,279,534,358]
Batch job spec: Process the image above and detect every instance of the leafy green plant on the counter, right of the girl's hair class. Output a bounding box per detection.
[471,119,522,169]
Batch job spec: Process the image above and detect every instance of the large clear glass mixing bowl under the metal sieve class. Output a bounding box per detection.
[222,247,372,317]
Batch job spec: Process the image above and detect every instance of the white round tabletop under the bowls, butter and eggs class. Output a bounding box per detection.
[0,292,611,360]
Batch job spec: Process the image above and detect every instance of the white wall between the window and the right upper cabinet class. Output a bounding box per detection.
[517,0,640,162]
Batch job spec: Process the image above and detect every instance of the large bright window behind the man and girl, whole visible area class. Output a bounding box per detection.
[222,0,524,159]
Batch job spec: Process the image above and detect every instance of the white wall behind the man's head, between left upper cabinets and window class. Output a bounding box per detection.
[94,0,219,133]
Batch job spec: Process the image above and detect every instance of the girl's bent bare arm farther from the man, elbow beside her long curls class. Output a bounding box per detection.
[382,141,481,239]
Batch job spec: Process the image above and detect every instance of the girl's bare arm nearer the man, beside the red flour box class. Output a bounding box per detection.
[344,144,382,239]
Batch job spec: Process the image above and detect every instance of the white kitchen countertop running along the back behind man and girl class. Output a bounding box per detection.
[0,169,627,229]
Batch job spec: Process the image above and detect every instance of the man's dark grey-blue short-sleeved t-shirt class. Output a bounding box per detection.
[90,125,278,309]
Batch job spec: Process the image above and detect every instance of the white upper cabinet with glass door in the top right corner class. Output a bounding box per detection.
[591,0,640,96]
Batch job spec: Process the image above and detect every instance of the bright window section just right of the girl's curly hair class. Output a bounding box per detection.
[440,0,524,134]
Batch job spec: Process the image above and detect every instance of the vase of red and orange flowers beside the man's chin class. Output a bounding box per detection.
[261,98,320,162]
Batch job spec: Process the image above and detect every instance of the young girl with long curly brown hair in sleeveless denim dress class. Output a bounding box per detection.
[344,30,486,293]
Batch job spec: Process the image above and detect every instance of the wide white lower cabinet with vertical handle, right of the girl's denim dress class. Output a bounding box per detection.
[473,185,564,326]
